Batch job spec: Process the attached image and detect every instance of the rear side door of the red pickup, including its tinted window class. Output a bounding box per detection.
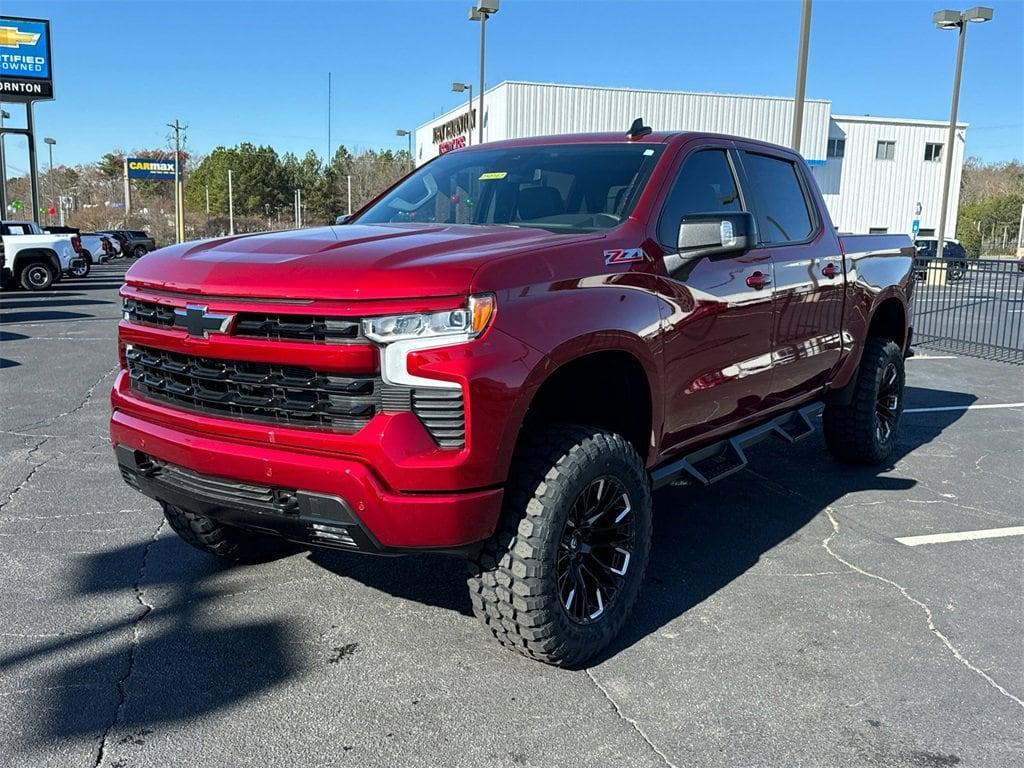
[738,146,846,408]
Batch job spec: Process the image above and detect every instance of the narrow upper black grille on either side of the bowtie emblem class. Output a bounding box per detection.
[124,299,366,344]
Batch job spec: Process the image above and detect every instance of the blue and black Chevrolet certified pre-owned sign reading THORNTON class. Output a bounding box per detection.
[0,16,53,101]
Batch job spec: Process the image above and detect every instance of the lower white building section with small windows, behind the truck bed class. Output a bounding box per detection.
[812,115,967,237]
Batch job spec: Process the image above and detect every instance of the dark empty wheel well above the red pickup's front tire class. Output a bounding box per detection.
[524,351,651,460]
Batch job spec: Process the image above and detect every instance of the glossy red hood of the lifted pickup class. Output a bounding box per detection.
[126,223,602,300]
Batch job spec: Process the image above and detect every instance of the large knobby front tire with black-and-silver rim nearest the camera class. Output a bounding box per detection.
[469,426,651,667]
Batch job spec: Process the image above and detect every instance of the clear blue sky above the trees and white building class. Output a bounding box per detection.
[3,0,1024,173]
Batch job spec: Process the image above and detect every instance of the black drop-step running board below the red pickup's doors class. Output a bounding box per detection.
[650,402,824,488]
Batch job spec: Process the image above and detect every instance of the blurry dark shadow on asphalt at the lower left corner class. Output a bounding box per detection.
[0,534,303,745]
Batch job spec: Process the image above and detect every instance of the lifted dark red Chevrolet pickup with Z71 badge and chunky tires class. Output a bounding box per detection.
[111,125,914,666]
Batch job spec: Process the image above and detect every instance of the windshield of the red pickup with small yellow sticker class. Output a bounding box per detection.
[353,144,663,232]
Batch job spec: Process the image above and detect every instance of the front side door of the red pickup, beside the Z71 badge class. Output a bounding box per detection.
[653,142,772,458]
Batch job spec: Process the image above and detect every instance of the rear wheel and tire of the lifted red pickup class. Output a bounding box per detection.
[823,339,905,464]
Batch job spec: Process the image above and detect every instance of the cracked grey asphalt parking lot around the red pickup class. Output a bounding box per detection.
[0,265,1024,768]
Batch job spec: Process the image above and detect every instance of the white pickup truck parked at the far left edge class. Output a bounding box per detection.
[0,220,85,291]
